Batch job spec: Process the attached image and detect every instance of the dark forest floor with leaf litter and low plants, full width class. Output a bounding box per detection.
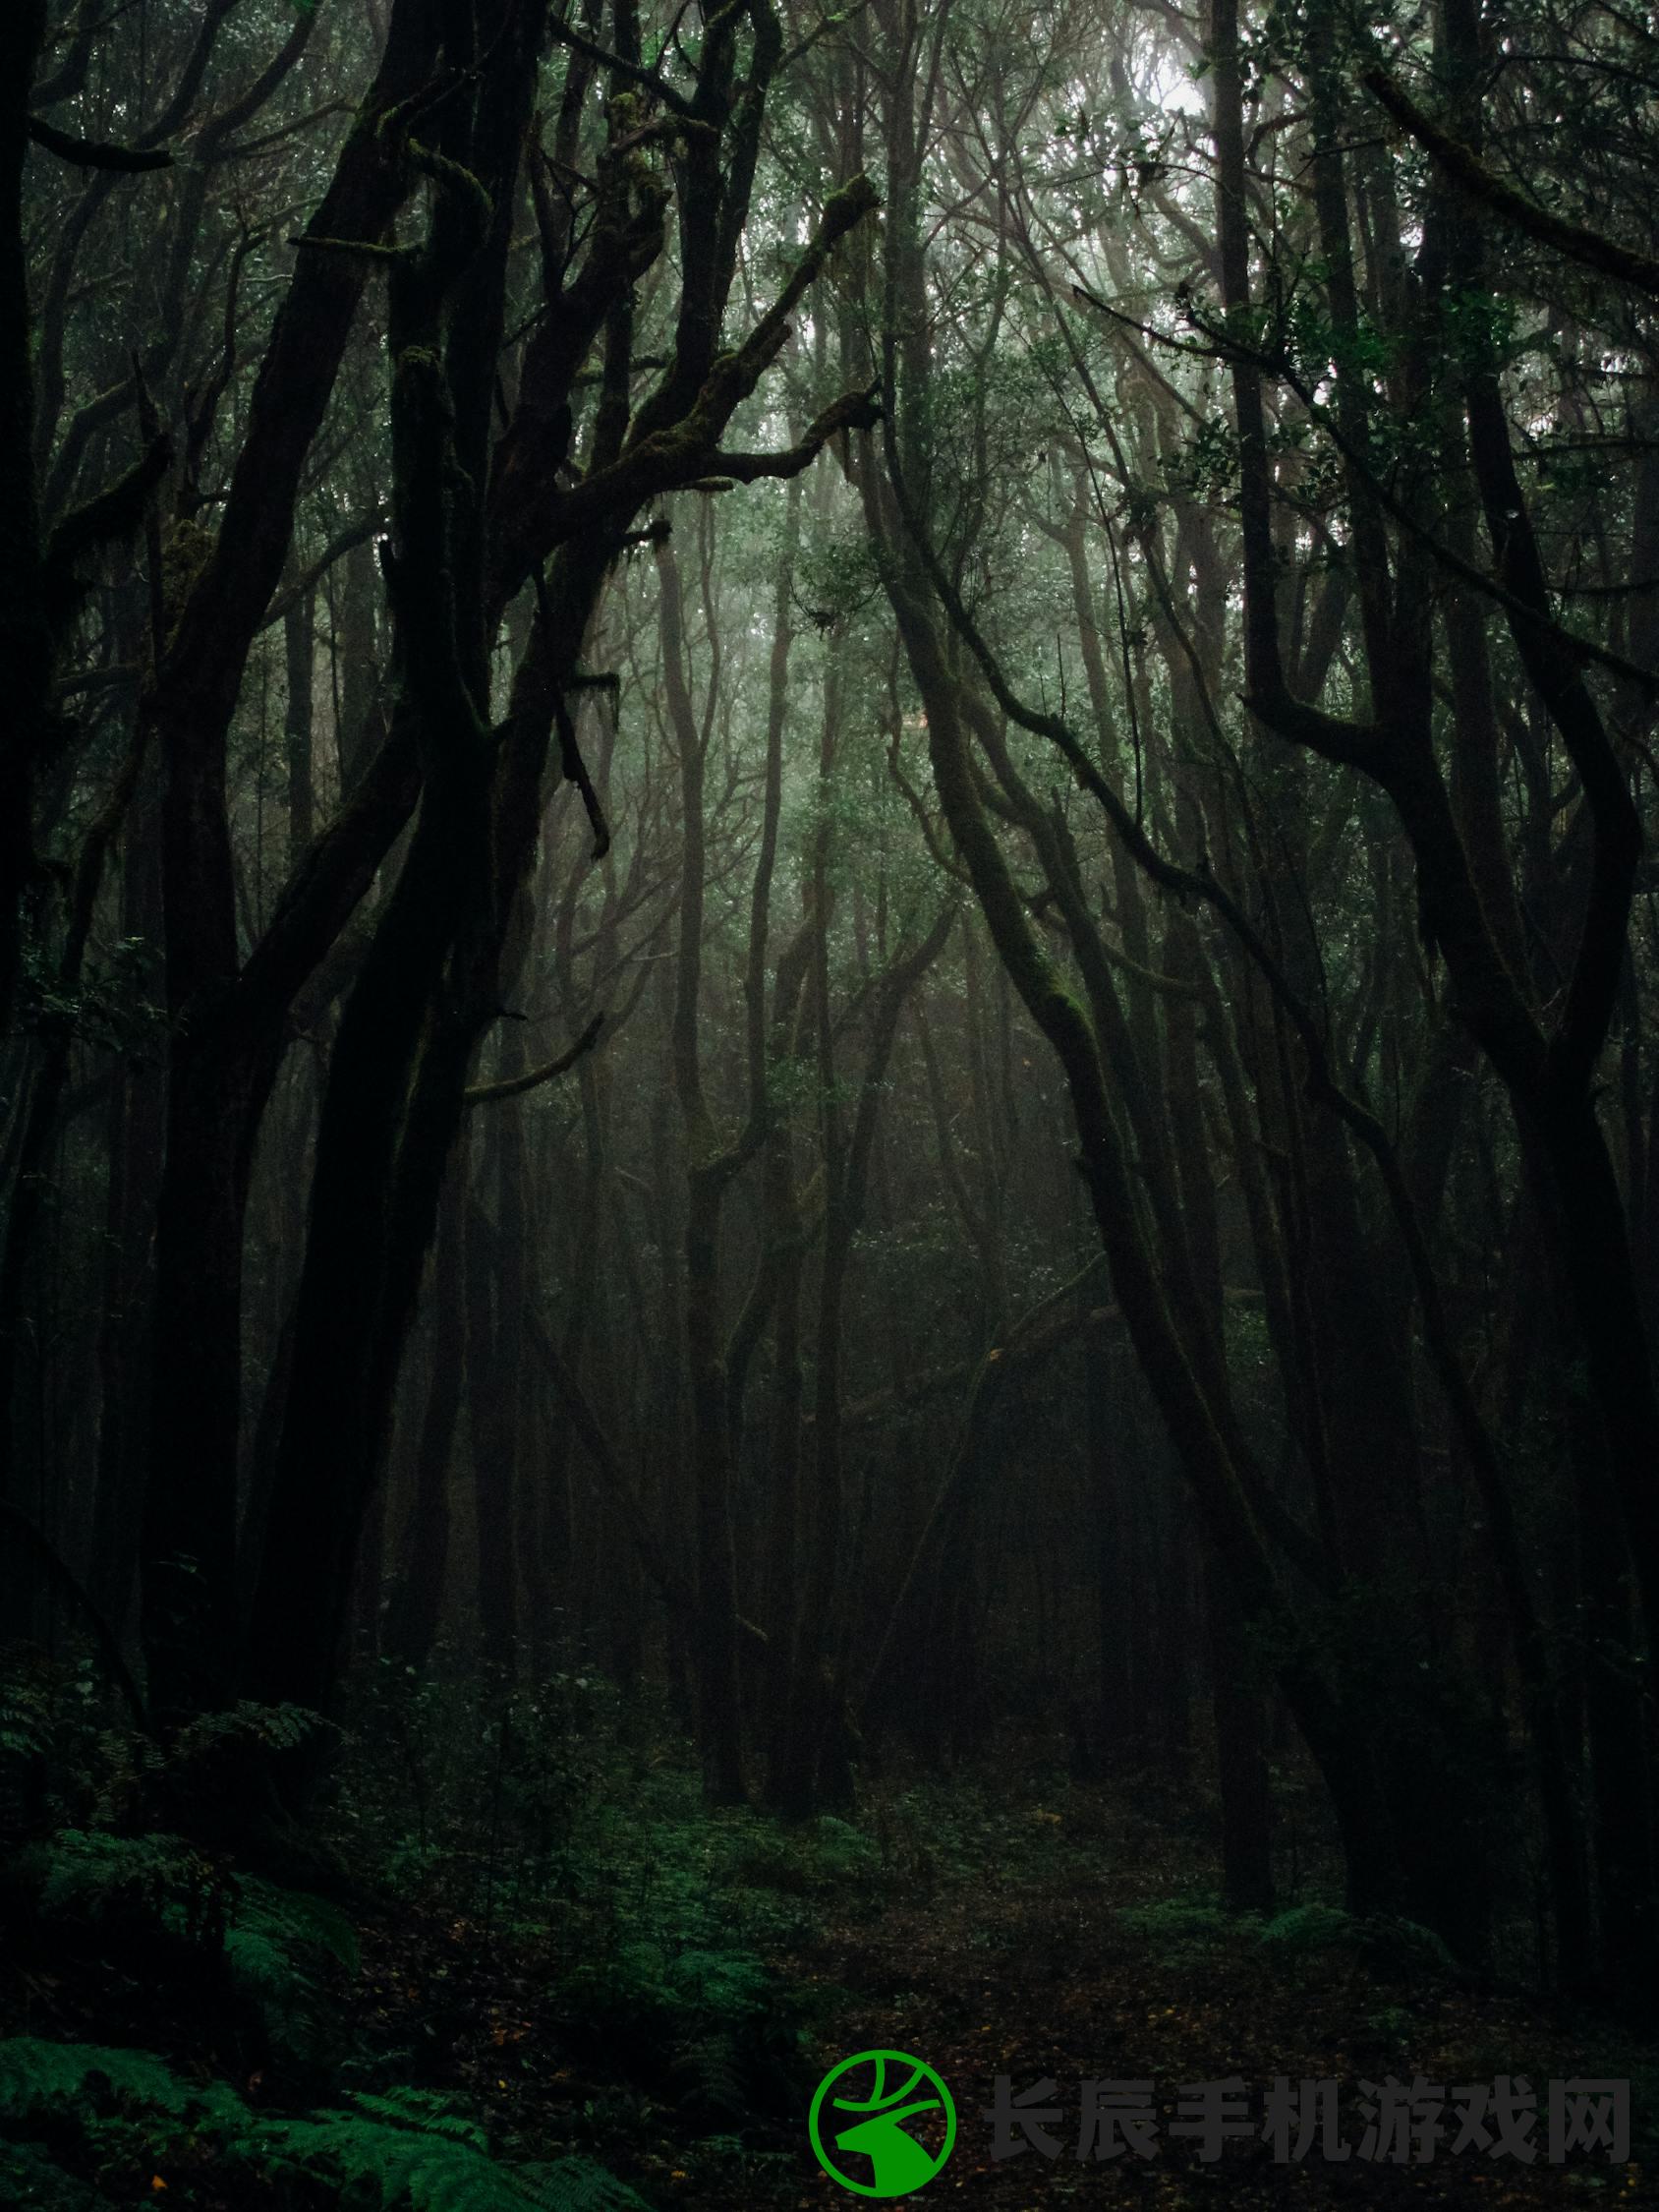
[0,1690,1659,2212]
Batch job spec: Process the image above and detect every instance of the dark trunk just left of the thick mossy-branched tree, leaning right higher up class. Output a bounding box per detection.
[143,0,433,1718]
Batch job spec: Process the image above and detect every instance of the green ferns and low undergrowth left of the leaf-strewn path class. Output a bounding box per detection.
[0,1668,891,2212]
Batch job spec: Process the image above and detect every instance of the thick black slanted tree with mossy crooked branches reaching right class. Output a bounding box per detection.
[250,0,874,1734]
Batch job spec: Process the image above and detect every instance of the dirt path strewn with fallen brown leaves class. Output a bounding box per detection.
[677,1807,1659,2212]
